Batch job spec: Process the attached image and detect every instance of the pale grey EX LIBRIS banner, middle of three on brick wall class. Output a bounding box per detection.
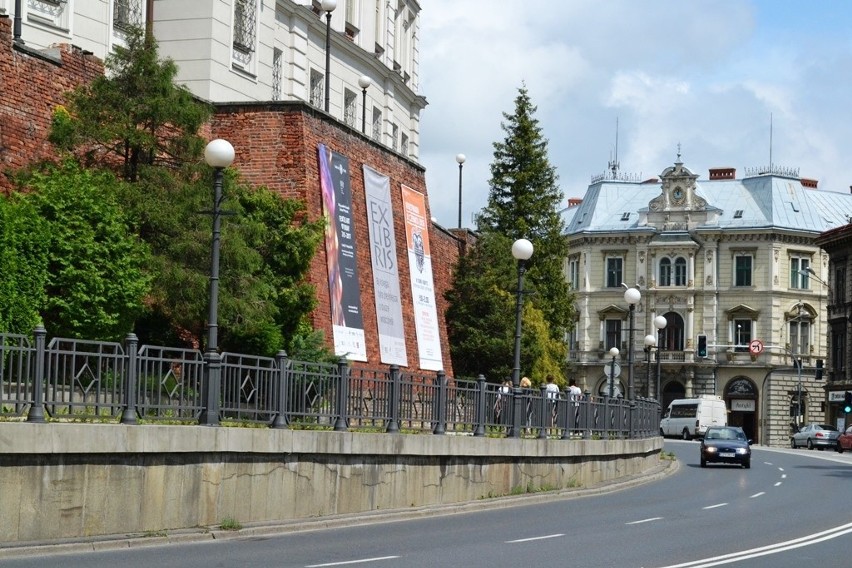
[363,166,408,367]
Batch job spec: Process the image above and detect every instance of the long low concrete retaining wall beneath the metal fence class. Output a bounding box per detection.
[0,423,662,542]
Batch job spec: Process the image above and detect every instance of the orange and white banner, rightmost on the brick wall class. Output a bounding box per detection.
[402,185,444,371]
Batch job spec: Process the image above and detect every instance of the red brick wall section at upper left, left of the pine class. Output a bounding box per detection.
[0,16,104,192]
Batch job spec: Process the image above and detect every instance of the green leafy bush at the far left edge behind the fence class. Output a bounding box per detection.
[0,194,50,335]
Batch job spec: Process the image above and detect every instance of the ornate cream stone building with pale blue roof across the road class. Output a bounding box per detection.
[563,155,852,446]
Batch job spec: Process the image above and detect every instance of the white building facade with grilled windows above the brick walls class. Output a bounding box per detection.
[0,0,426,161]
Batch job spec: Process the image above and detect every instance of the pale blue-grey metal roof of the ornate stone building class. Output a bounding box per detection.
[561,175,852,235]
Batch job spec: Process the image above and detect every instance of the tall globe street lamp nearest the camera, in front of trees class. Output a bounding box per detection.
[199,138,234,426]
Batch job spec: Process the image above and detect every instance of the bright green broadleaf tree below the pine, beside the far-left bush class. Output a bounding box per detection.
[18,160,149,340]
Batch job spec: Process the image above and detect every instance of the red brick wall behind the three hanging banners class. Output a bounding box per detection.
[211,102,459,376]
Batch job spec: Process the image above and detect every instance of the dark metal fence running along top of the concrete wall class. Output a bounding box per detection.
[0,327,660,439]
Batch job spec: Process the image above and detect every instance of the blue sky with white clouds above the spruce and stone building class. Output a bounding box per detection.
[419,0,852,228]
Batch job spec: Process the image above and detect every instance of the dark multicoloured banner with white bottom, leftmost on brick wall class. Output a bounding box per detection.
[317,144,367,361]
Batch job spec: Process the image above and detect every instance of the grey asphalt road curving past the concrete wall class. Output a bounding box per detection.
[0,441,852,568]
